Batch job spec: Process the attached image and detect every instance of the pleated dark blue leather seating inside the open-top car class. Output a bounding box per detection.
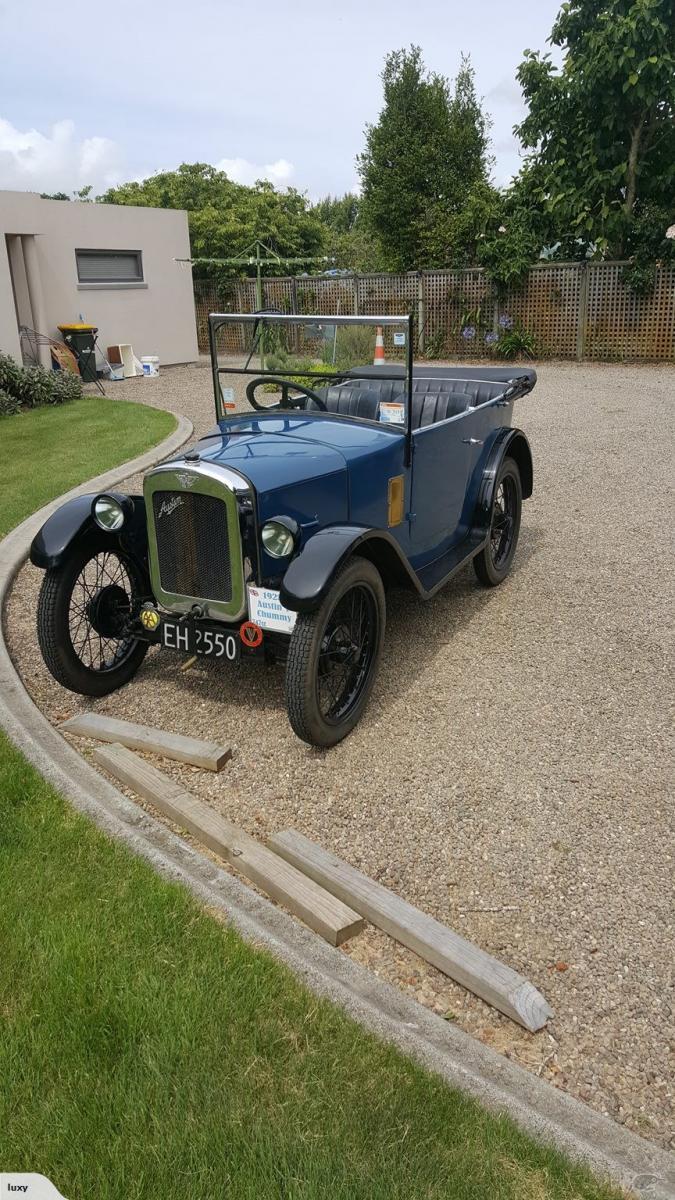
[307,377,504,430]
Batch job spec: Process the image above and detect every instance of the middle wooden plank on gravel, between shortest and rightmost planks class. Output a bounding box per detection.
[94,745,364,946]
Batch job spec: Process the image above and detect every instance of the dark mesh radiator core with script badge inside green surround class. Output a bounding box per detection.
[153,491,232,604]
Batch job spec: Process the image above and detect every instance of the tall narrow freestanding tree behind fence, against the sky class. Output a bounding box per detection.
[357,46,490,270]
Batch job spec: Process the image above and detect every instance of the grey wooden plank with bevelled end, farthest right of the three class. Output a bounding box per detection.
[268,829,554,1032]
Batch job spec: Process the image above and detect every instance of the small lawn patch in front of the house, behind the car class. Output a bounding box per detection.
[0,396,175,536]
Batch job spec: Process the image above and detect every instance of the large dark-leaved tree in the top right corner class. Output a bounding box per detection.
[516,0,675,257]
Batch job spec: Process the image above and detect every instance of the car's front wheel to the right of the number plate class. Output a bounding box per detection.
[286,557,387,746]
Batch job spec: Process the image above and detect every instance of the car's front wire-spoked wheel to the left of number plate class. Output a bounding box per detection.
[37,535,148,696]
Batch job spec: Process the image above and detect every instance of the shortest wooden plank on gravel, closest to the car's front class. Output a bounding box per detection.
[60,713,232,770]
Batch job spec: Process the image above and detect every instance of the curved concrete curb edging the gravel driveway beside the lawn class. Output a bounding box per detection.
[0,418,675,1200]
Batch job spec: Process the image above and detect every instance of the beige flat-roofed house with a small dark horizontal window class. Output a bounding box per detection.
[0,191,198,366]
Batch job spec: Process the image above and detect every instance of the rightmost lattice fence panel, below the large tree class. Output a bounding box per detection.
[585,270,675,361]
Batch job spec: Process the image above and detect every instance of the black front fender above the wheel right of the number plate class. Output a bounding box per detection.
[280,526,422,612]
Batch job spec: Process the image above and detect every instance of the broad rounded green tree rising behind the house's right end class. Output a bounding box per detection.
[98,162,324,278]
